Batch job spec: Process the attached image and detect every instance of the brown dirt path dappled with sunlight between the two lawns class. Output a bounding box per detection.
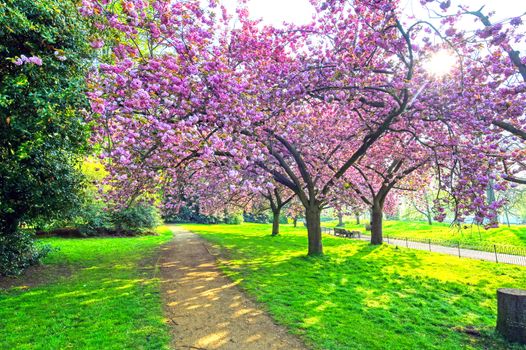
[159,227,305,350]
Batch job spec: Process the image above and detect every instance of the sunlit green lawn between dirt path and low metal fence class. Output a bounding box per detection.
[185,224,526,349]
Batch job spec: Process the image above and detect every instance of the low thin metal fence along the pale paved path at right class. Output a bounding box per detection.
[322,227,526,266]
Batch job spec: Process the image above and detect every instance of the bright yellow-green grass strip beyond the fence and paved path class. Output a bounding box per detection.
[330,221,526,248]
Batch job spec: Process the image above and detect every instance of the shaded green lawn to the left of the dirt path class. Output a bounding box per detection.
[0,229,171,349]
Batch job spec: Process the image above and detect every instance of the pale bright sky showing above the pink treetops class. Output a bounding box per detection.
[223,0,526,25]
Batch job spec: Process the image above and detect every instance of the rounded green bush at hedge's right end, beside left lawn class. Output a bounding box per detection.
[111,204,162,233]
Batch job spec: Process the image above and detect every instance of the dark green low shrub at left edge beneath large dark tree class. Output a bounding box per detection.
[0,231,51,276]
